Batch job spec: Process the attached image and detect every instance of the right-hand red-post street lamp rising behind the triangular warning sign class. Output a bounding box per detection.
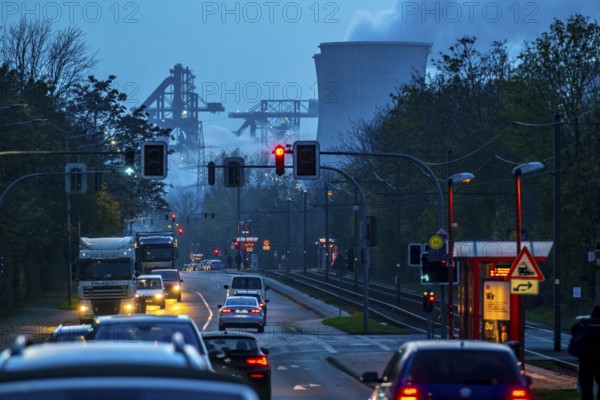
[510,161,544,365]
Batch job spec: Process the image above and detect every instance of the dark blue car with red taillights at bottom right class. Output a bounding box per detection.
[362,340,533,400]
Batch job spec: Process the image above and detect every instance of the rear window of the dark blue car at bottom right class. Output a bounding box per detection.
[408,350,518,384]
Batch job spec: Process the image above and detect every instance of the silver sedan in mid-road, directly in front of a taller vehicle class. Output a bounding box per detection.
[217,296,266,333]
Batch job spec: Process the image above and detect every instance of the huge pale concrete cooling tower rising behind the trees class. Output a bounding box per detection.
[313,42,431,150]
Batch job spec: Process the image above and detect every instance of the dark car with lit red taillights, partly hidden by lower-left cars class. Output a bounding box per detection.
[202,332,271,400]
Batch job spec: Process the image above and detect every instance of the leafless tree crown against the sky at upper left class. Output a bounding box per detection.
[0,18,97,99]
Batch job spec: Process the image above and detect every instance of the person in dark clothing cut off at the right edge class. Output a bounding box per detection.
[570,306,600,400]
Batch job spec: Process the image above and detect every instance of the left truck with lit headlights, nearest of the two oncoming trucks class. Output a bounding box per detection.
[76,236,136,323]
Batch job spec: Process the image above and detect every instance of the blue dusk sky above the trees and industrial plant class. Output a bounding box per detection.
[5,0,600,153]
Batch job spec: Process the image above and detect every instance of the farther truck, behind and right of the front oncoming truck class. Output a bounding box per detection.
[135,231,179,274]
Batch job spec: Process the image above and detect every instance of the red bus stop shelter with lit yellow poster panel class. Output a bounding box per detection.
[453,240,553,342]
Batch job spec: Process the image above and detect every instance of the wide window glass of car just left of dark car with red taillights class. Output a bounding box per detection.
[93,321,203,353]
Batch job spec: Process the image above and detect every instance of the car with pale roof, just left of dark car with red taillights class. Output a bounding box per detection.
[89,314,210,364]
